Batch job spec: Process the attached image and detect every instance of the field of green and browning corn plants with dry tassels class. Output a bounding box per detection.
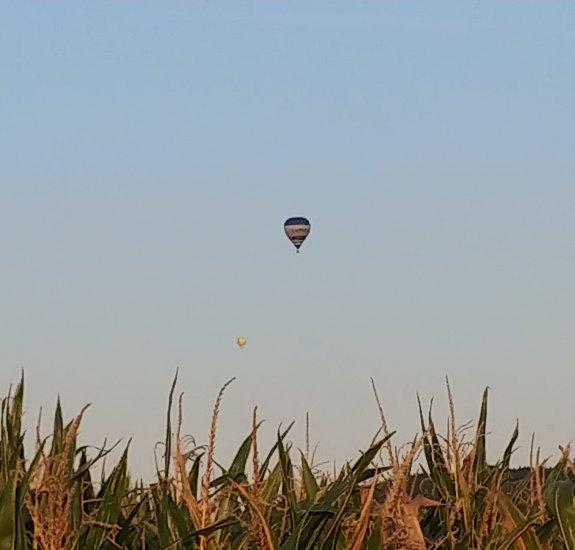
[0,375,575,550]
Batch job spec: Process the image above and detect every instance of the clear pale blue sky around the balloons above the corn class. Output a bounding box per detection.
[0,0,575,477]
